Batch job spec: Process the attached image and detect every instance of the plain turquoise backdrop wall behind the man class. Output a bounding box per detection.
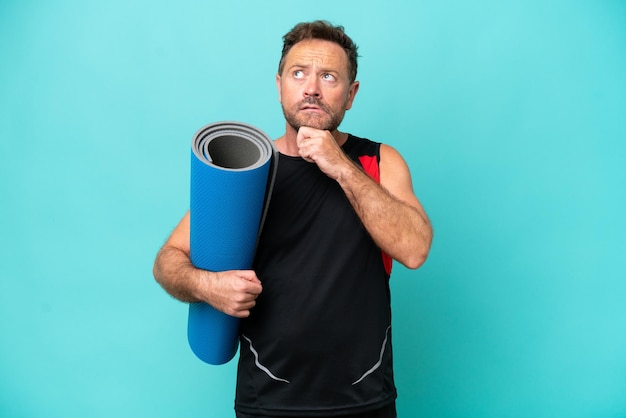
[0,0,626,418]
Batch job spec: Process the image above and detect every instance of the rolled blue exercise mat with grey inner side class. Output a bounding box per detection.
[187,122,278,365]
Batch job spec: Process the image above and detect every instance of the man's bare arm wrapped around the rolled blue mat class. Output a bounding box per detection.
[153,212,262,318]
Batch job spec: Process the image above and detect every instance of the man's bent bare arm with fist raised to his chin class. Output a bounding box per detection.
[297,127,433,269]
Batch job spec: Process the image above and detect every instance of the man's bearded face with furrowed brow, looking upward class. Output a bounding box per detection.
[276,39,359,132]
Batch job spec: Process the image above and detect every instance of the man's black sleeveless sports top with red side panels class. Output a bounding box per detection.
[235,135,396,417]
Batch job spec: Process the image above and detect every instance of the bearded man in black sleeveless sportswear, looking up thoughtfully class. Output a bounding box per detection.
[154,21,432,418]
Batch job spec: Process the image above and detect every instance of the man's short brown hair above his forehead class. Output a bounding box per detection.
[278,20,358,82]
